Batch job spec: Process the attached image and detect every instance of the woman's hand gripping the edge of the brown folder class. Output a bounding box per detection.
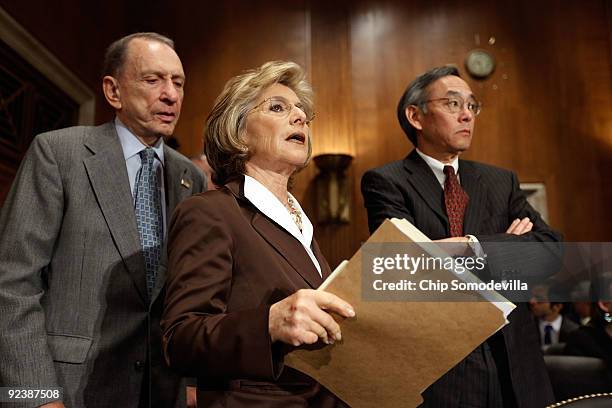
[268,289,355,346]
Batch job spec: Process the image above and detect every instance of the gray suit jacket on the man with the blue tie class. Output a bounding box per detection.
[0,122,206,408]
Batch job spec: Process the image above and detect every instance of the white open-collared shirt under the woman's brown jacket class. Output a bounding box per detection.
[244,174,323,277]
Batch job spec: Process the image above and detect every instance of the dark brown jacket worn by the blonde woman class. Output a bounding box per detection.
[162,179,346,408]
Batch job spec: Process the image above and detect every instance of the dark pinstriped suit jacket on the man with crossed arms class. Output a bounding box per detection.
[361,150,560,408]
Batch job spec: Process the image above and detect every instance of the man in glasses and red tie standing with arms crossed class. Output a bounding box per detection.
[362,67,560,408]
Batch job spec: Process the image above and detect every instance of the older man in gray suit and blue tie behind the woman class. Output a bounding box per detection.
[0,33,206,408]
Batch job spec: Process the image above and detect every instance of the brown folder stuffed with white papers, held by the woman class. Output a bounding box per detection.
[285,220,514,408]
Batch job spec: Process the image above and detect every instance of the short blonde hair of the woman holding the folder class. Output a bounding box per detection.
[204,61,313,186]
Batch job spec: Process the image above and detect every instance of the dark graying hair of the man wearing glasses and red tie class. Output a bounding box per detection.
[397,65,461,147]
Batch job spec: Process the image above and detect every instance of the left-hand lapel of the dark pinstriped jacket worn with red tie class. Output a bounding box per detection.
[404,149,448,229]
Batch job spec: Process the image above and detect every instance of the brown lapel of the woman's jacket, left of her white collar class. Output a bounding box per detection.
[226,178,322,289]
